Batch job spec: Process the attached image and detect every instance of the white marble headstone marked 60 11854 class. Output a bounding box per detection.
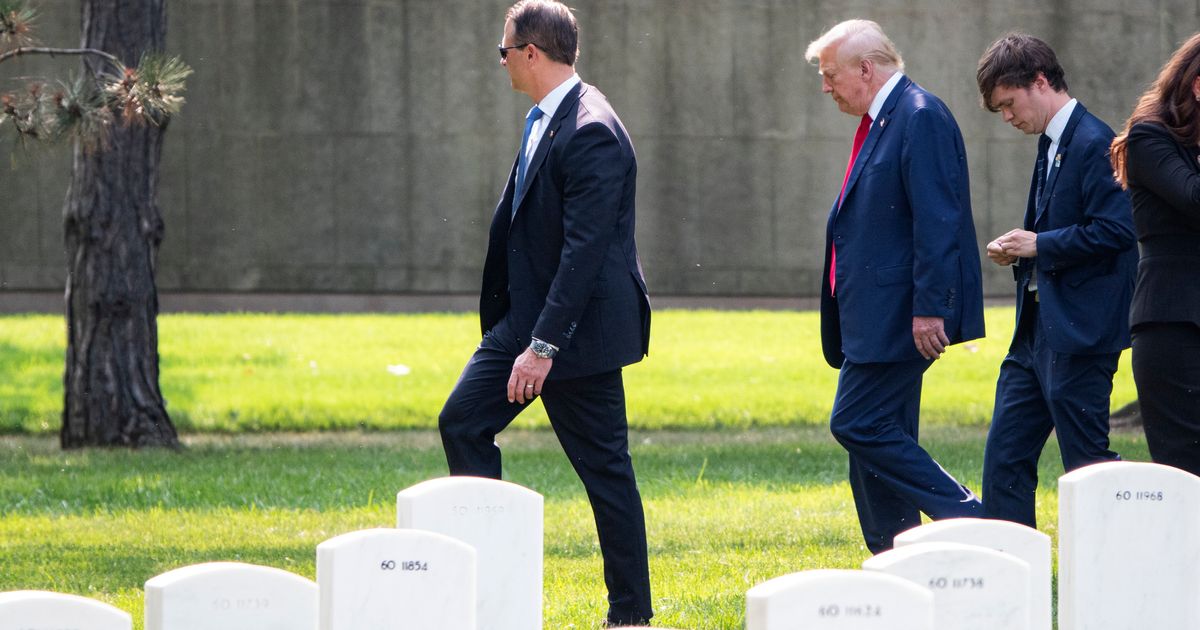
[317,529,475,630]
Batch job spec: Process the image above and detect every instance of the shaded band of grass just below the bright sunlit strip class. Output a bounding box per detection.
[0,428,1148,515]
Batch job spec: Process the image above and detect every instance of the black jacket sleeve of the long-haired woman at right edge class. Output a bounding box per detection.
[1126,126,1200,216]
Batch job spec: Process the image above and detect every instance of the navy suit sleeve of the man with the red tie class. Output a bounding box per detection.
[900,107,970,318]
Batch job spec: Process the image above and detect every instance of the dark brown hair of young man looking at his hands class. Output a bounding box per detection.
[976,32,1067,112]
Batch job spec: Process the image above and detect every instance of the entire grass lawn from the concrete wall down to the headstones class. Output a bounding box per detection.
[0,308,1147,630]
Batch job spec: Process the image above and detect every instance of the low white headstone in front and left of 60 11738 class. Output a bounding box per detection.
[746,569,934,630]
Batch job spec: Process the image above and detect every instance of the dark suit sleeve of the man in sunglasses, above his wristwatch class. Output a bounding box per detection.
[533,122,629,349]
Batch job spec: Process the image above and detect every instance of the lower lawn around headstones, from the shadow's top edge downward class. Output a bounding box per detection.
[0,426,1147,630]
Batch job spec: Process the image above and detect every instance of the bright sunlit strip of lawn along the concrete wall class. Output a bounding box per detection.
[0,307,1136,433]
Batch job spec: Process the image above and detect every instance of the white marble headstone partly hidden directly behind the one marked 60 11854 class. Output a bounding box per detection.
[396,476,542,630]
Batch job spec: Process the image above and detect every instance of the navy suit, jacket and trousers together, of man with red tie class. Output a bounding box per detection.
[821,77,984,553]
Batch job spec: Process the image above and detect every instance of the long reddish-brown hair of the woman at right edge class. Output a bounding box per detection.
[1110,32,1200,188]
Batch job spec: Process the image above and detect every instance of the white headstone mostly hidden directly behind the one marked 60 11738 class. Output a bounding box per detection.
[895,518,1052,630]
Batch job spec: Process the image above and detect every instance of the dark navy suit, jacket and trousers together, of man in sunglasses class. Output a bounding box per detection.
[438,83,653,624]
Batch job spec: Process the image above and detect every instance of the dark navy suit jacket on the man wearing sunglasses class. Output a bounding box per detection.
[479,83,650,379]
